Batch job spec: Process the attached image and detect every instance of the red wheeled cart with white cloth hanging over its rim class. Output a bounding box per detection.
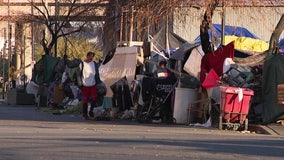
[219,86,254,130]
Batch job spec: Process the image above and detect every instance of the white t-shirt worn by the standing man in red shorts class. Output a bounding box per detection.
[82,61,96,87]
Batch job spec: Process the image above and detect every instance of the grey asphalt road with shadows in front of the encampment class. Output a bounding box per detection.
[0,104,284,160]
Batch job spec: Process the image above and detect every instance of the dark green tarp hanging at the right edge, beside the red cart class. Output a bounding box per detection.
[262,54,284,124]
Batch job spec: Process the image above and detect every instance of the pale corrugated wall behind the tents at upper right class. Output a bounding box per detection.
[173,7,284,41]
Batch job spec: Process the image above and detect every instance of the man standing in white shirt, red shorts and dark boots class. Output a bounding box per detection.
[78,52,101,120]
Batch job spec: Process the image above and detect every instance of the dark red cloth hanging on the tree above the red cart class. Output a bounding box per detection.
[200,41,235,82]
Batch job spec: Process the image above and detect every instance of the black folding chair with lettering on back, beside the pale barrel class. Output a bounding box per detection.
[137,77,178,123]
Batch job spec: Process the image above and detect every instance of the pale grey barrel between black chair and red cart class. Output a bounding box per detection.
[173,88,199,124]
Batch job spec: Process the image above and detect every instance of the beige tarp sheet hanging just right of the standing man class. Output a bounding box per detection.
[99,47,138,97]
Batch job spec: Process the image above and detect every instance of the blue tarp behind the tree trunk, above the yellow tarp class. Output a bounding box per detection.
[195,24,260,41]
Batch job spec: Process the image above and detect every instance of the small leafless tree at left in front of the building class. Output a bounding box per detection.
[25,0,108,56]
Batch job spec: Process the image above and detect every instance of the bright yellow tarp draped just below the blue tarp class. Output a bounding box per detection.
[217,36,269,52]
